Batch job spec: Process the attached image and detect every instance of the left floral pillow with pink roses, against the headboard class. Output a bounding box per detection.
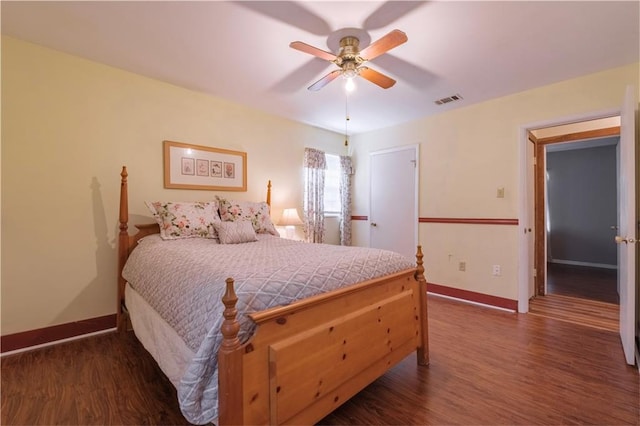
[145,201,220,240]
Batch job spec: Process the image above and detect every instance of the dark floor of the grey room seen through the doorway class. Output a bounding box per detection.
[547,263,620,304]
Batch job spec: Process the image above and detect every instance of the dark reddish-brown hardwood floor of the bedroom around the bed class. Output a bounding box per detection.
[0,295,640,425]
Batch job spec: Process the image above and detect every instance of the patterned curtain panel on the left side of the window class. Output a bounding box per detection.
[303,148,327,243]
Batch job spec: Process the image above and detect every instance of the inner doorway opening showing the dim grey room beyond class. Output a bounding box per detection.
[538,136,620,304]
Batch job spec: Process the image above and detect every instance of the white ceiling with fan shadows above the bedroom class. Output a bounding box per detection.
[1,0,640,134]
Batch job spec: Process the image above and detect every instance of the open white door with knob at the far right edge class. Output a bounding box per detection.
[616,87,638,365]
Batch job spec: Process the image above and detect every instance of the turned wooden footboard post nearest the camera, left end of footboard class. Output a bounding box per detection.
[218,278,244,425]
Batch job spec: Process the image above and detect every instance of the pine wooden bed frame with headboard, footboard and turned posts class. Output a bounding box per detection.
[117,167,429,425]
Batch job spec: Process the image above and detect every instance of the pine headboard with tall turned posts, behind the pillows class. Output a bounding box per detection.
[116,166,271,331]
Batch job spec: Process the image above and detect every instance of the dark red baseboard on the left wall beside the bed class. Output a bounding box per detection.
[0,314,116,354]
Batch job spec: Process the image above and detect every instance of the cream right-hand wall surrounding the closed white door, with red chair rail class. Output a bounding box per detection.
[351,64,639,300]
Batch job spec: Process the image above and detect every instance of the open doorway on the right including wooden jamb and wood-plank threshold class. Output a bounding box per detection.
[529,117,620,331]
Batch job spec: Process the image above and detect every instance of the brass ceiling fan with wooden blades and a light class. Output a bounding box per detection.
[289,30,408,91]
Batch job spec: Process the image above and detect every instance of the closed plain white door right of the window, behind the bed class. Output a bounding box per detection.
[369,145,418,259]
